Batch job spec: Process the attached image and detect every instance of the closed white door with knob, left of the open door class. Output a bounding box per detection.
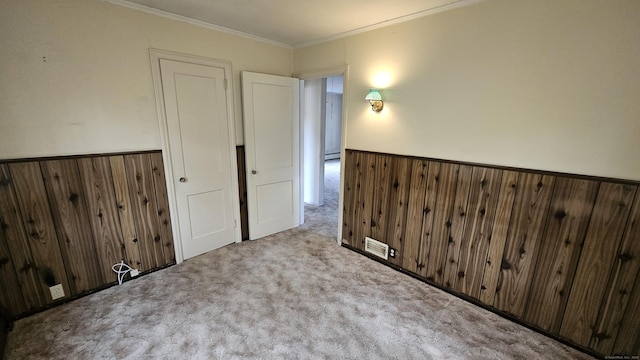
[159,59,237,259]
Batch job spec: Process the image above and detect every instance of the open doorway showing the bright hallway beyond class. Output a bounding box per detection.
[301,74,344,238]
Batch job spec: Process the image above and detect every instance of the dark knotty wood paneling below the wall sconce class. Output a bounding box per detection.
[342,150,640,355]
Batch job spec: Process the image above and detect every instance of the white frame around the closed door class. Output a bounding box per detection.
[149,48,242,264]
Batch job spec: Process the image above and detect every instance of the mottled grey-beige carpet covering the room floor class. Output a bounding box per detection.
[6,161,590,359]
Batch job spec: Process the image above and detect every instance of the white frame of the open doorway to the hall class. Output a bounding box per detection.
[293,65,349,245]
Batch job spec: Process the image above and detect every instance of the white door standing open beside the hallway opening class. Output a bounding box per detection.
[242,71,301,240]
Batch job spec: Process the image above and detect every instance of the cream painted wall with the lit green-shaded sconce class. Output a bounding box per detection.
[294,0,640,180]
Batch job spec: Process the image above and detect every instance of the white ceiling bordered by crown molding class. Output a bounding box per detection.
[106,0,481,47]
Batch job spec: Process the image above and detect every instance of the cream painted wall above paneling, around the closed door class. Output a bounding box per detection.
[0,0,293,159]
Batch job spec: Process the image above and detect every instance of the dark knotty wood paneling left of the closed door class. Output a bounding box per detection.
[0,151,175,317]
